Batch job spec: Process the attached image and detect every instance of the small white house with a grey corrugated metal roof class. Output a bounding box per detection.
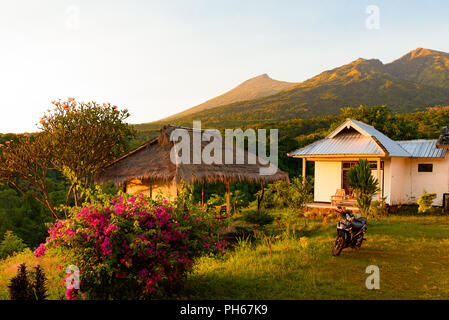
[288,119,449,206]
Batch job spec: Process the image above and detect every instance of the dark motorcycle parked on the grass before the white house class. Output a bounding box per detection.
[332,207,367,256]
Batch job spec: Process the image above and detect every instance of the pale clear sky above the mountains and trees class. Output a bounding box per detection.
[0,0,449,133]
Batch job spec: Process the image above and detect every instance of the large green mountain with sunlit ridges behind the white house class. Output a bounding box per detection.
[136,48,449,127]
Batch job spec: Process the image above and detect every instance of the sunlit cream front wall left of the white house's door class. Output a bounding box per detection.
[314,161,342,202]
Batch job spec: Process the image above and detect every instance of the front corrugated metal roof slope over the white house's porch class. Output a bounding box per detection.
[290,134,384,156]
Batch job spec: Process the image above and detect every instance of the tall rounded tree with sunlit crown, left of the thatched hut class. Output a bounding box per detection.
[39,98,134,205]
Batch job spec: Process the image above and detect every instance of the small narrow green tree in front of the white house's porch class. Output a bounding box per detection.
[348,159,379,215]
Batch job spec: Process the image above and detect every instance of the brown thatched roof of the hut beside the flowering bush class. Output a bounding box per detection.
[95,125,288,185]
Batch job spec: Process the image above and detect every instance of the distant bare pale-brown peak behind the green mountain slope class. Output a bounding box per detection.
[161,73,296,121]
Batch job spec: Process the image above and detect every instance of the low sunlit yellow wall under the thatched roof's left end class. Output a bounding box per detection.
[126,180,177,200]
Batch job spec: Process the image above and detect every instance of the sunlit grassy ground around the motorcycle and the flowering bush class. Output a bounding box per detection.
[0,212,449,299]
